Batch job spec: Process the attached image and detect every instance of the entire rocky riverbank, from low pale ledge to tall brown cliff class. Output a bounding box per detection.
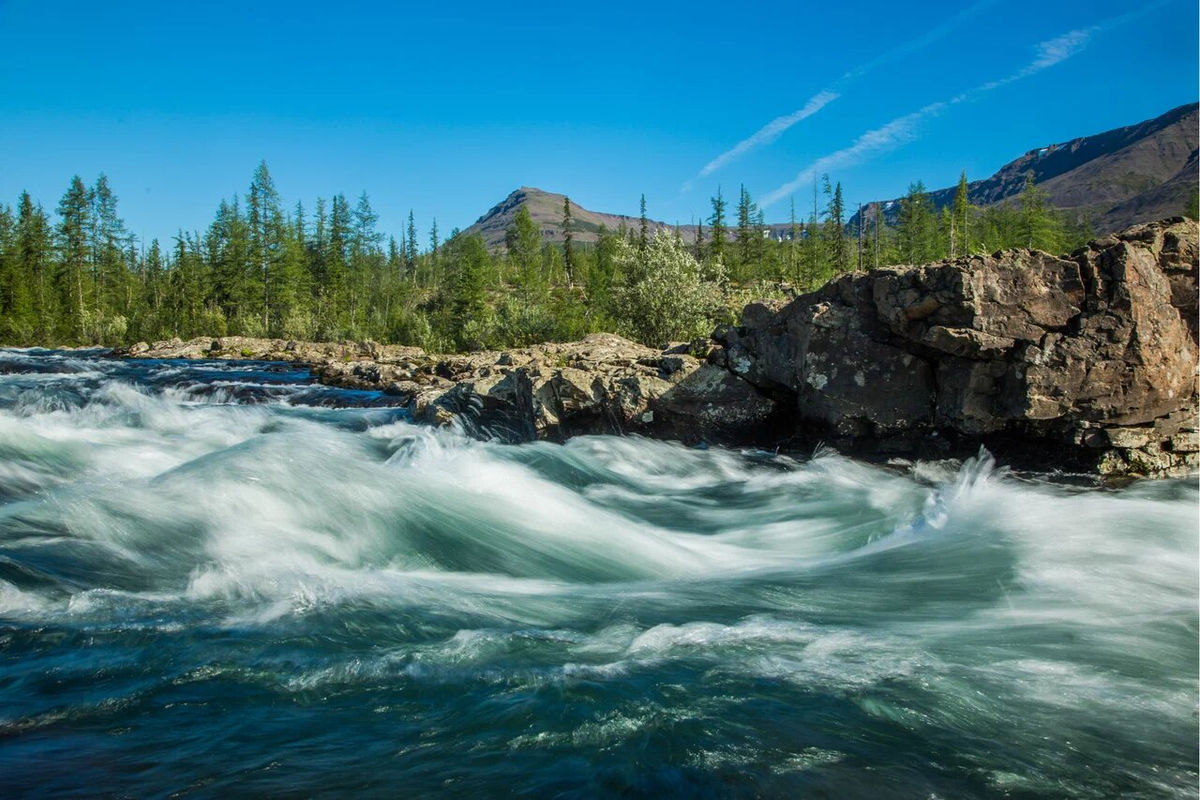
[126,218,1200,475]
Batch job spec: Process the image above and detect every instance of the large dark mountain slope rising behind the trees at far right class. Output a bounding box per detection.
[851,103,1200,234]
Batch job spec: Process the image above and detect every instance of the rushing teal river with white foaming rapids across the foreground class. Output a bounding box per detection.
[0,350,1200,798]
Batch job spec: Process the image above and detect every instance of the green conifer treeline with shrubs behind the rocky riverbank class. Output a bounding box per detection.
[0,163,1104,350]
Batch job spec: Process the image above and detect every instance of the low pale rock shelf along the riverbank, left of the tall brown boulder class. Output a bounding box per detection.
[116,333,781,444]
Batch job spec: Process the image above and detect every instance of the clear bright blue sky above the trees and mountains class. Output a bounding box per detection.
[0,0,1198,240]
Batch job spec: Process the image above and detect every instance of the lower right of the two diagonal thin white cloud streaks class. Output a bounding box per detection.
[758,20,1118,207]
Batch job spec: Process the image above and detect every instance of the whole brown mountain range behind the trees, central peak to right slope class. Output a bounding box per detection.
[463,103,1200,249]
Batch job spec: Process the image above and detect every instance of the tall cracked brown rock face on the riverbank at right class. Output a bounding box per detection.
[718,218,1196,474]
